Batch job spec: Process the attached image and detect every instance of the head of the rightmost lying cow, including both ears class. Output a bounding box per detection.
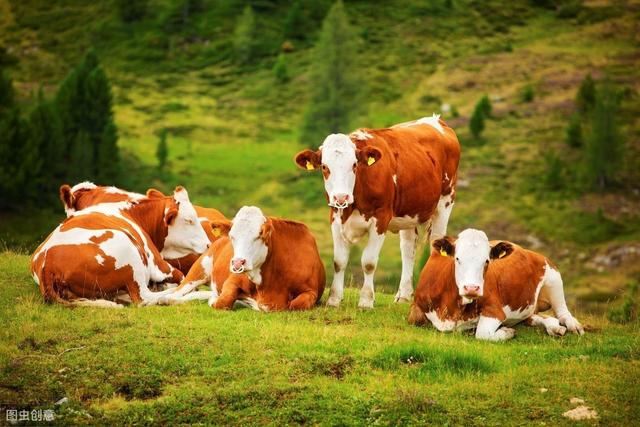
[432,228,513,303]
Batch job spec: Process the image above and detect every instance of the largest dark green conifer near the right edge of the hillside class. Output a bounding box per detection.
[585,82,624,189]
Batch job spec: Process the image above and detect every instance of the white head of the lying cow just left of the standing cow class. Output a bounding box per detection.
[229,206,273,273]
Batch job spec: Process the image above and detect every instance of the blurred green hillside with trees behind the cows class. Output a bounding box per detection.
[0,0,640,321]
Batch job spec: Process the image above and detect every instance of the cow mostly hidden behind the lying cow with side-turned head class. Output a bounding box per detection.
[60,181,230,274]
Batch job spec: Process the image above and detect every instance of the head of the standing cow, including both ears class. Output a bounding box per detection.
[295,133,382,209]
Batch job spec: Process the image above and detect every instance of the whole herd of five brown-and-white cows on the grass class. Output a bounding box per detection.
[31,115,583,340]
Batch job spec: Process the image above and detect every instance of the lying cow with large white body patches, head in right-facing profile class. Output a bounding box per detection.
[31,187,210,307]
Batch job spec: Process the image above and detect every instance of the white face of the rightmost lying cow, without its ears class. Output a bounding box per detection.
[454,228,491,296]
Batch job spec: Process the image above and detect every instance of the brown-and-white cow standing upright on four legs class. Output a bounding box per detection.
[295,115,460,308]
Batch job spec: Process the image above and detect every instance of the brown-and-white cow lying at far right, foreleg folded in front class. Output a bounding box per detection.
[408,229,584,341]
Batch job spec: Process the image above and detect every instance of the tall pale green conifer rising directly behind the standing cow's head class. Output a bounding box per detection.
[301,0,362,146]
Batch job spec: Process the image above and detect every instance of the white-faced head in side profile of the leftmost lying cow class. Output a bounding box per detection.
[162,186,210,259]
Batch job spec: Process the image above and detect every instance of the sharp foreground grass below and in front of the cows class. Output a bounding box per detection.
[0,252,640,425]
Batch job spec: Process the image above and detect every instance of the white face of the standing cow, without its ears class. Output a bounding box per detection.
[320,133,357,208]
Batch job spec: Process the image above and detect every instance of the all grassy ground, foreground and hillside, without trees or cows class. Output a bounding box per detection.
[0,0,640,425]
